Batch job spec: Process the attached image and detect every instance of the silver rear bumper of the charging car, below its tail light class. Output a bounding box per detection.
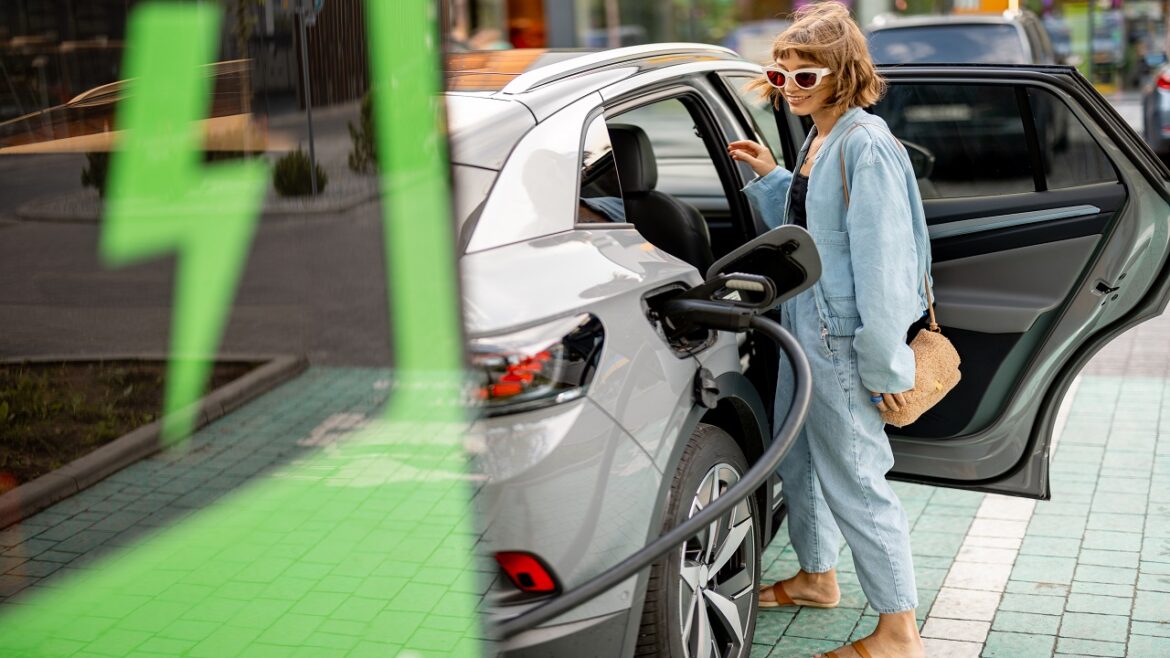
[470,399,662,646]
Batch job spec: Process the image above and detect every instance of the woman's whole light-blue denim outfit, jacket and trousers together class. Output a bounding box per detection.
[744,109,930,614]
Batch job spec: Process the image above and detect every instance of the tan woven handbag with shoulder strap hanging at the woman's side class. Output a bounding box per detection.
[841,135,962,427]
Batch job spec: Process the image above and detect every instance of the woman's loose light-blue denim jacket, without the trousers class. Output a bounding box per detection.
[743,108,930,393]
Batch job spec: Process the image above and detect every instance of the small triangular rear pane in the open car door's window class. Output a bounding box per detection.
[1028,89,1117,190]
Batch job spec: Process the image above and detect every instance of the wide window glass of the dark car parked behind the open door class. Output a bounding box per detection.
[869,23,1027,64]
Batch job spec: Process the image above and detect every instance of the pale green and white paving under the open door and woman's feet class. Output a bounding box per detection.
[751,309,1170,658]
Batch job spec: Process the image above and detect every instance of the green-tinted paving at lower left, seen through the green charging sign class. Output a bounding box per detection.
[0,368,486,658]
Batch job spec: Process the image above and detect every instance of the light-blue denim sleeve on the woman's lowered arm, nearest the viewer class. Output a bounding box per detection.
[846,136,921,393]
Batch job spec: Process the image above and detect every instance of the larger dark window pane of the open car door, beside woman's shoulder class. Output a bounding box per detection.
[873,83,1035,199]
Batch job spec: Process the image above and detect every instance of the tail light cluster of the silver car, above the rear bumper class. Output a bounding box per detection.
[470,314,605,416]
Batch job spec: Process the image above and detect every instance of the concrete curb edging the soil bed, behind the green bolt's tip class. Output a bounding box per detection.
[0,356,309,529]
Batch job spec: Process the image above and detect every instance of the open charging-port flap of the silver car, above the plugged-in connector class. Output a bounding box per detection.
[707,225,820,306]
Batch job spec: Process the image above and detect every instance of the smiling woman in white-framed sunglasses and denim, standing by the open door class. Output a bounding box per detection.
[728,2,930,658]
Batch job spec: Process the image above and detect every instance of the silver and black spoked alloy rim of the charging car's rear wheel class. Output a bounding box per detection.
[679,462,756,658]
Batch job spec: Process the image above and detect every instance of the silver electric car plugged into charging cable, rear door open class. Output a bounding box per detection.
[456,44,1170,657]
